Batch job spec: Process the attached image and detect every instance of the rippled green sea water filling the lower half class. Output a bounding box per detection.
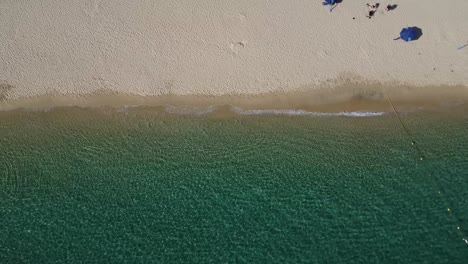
[0,109,468,263]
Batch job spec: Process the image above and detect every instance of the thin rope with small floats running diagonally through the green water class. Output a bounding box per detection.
[382,94,468,245]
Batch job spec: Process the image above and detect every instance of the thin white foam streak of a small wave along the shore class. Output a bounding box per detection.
[231,106,385,117]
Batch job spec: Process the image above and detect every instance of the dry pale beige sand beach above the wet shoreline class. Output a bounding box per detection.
[0,0,468,109]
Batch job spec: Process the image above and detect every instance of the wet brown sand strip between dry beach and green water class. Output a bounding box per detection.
[0,83,468,113]
